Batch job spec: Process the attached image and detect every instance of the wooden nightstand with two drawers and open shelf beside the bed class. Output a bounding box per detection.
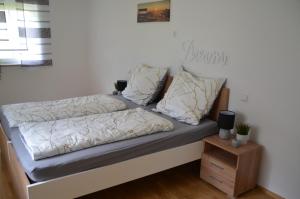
[200,135,262,196]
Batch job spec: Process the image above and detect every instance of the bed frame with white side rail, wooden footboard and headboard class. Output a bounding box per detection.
[0,77,229,199]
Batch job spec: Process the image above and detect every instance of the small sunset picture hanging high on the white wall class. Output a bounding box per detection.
[137,0,170,23]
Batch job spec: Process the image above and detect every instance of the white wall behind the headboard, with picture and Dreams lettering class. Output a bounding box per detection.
[89,0,300,199]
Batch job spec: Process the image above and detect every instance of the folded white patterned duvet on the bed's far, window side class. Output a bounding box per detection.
[2,95,127,127]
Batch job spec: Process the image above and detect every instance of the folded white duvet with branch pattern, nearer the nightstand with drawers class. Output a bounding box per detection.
[19,108,174,160]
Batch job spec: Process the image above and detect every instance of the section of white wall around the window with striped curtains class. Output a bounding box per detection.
[0,0,90,104]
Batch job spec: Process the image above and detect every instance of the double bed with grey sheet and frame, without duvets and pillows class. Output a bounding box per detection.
[0,77,229,199]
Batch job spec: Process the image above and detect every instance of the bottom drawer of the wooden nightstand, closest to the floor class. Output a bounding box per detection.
[200,167,234,195]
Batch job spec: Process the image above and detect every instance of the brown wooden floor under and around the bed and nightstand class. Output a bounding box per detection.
[0,162,273,199]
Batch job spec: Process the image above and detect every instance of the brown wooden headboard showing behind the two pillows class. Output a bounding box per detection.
[160,76,230,121]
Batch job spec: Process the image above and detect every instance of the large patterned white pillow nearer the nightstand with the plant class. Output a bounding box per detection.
[156,71,225,125]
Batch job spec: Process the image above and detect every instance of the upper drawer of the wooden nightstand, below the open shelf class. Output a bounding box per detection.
[201,154,236,182]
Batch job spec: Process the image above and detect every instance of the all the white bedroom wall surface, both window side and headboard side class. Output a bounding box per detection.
[0,0,300,199]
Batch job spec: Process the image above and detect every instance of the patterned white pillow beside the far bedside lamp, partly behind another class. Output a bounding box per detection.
[122,65,168,106]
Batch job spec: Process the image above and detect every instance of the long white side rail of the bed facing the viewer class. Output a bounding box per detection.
[27,141,202,199]
